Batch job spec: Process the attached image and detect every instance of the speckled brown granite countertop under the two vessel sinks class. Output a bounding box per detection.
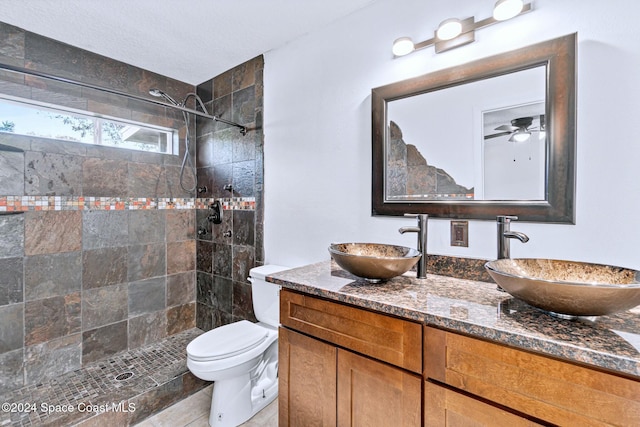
[267,261,640,379]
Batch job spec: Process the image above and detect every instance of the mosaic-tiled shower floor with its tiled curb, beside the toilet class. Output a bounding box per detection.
[0,329,207,427]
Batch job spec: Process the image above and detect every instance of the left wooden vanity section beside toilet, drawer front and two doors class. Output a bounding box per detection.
[279,290,422,427]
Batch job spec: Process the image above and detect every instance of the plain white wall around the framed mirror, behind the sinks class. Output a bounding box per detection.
[264,0,640,268]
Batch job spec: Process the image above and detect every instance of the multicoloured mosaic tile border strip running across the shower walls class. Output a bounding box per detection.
[0,196,256,212]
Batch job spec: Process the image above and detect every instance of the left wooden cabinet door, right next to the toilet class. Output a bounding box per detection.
[278,328,336,427]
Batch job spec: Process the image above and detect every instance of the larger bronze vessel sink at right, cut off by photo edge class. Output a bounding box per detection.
[485,258,640,317]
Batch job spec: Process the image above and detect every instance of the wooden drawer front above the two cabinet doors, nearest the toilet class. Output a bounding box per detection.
[280,289,422,373]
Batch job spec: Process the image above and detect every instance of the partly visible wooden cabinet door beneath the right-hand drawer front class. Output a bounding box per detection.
[424,381,542,427]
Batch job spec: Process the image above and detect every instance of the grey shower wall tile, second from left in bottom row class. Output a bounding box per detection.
[24,334,82,385]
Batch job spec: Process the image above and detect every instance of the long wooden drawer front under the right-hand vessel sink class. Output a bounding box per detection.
[424,327,640,426]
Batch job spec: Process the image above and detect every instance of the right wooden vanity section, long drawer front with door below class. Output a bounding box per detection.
[424,327,640,426]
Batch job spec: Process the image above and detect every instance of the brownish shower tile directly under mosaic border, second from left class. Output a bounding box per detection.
[24,211,82,255]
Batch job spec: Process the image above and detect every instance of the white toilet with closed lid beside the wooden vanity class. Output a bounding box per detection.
[187,265,288,427]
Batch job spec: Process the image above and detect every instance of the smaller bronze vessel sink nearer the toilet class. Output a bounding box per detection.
[329,243,422,282]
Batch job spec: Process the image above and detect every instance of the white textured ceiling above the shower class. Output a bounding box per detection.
[0,0,375,84]
